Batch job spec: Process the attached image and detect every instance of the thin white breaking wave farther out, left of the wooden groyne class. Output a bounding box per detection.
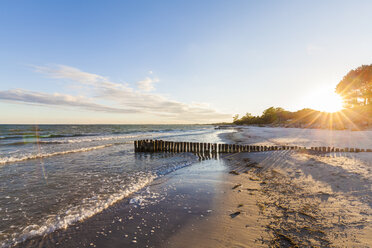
[0,144,114,164]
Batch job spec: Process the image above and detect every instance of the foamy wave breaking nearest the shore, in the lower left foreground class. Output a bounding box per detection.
[0,173,156,247]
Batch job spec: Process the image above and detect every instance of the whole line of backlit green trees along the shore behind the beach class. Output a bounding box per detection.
[233,64,372,129]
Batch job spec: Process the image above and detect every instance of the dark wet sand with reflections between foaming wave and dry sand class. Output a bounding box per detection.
[18,156,227,247]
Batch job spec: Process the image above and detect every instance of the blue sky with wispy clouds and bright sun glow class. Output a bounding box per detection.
[0,0,372,124]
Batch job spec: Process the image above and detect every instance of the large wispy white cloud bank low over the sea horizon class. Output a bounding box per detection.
[0,65,231,122]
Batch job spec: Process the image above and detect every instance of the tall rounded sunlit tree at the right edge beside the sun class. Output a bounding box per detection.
[336,64,372,107]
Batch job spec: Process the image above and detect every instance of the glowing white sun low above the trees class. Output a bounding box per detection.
[305,88,343,113]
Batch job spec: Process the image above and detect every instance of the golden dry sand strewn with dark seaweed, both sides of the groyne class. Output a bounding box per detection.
[169,127,372,247]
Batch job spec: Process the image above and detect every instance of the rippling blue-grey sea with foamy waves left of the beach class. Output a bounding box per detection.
[0,125,227,247]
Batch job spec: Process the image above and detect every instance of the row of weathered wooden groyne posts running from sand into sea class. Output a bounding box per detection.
[134,140,372,154]
